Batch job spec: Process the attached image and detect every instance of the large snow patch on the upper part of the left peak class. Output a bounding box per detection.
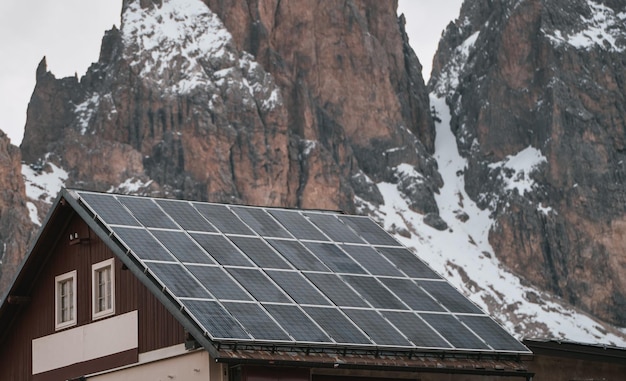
[121,0,282,112]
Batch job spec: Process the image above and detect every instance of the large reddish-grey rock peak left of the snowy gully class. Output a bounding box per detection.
[22,0,441,213]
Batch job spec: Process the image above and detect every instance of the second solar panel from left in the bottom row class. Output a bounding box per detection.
[224,302,291,341]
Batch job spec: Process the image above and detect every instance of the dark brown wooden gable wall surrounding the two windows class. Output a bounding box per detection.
[0,213,185,381]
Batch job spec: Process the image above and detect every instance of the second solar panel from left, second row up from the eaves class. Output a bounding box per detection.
[187,265,252,300]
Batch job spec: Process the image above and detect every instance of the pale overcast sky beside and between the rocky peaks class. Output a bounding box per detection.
[0,0,462,145]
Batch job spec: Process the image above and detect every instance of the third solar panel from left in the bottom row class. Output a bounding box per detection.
[264,304,332,343]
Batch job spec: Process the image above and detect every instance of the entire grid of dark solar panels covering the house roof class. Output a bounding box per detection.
[76,191,528,353]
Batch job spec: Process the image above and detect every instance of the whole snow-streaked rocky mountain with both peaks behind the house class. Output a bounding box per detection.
[1,0,626,346]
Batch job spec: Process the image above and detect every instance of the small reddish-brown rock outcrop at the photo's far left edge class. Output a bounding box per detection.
[0,131,34,297]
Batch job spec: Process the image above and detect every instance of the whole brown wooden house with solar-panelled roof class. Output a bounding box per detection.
[0,190,533,381]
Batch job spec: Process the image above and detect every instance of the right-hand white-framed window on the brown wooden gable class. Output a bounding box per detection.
[91,258,115,319]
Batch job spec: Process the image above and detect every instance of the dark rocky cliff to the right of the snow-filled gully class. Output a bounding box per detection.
[429,0,626,326]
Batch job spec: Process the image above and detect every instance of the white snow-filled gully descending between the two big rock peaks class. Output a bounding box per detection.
[364,94,626,347]
